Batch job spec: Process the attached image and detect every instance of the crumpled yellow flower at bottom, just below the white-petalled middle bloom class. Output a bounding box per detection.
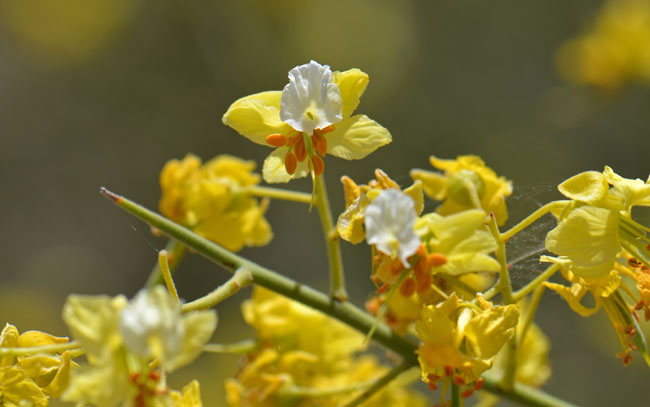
[416,294,519,390]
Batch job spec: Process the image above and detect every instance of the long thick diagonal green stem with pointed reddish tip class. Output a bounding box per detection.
[101,188,573,407]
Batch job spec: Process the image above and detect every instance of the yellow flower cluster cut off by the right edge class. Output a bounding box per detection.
[542,167,650,364]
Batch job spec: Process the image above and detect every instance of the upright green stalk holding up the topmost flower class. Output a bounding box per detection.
[314,175,348,301]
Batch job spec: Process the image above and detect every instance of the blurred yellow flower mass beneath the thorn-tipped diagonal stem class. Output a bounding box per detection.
[226,287,426,407]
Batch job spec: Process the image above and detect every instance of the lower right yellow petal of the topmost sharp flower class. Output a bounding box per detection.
[324,115,392,161]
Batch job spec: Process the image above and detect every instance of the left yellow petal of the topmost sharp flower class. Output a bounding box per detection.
[221,91,291,146]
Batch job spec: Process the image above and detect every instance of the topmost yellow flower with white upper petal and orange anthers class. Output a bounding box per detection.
[223,61,391,183]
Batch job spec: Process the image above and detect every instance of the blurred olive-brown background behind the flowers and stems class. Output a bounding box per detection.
[0,0,650,406]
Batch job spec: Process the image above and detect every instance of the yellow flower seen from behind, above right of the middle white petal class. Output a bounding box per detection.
[411,155,512,225]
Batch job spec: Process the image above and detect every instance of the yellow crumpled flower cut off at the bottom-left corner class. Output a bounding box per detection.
[0,324,71,406]
